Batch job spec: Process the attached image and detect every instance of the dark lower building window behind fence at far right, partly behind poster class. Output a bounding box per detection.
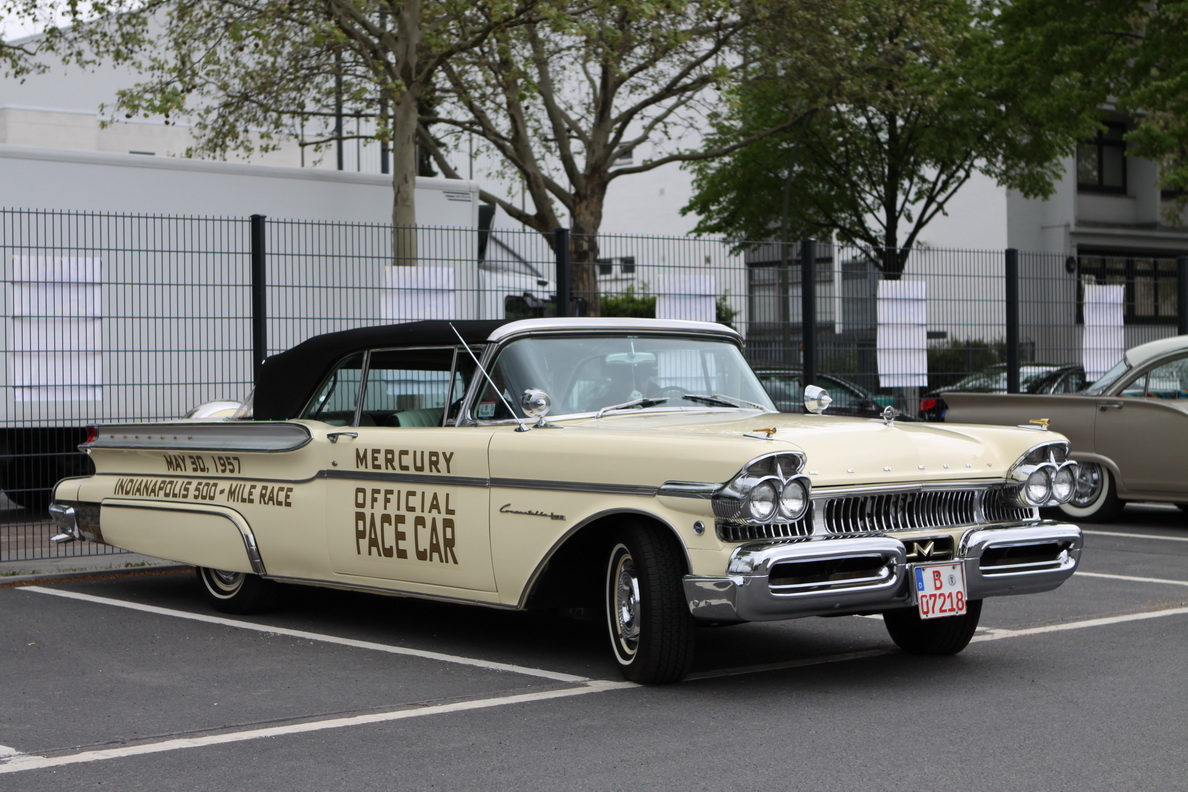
[1078,251,1178,324]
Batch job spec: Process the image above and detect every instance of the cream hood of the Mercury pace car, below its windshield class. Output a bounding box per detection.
[532,411,1064,487]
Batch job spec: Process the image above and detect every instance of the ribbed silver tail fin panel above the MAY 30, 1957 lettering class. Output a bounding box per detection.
[82,422,312,454]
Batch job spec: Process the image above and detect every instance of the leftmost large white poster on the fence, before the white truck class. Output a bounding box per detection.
[8,255,103,401]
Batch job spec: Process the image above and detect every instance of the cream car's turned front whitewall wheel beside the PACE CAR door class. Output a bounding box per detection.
[605,525,696,685]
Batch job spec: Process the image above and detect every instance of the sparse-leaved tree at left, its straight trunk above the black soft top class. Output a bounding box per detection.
[52,0,537,262]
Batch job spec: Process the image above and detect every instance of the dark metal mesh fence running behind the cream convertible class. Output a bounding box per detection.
[0,210,1180,560]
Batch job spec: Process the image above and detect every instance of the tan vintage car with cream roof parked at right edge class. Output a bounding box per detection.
[944,336,1188,521]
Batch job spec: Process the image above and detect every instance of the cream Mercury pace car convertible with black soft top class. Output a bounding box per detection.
[51,319,1082,683]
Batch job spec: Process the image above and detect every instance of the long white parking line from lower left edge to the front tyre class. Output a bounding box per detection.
[0,682,636,775]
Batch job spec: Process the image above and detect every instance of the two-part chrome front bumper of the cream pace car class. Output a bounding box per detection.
[684,521,1083,621]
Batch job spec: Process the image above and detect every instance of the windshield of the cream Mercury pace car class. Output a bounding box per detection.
[474,335,775,420]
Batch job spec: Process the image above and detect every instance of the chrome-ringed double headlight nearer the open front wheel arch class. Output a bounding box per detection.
[713,454,811,525]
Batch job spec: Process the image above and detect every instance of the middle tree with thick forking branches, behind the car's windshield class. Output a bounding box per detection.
[421,0,855,313]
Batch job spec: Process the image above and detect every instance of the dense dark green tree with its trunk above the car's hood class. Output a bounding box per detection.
[684,0,1097,279]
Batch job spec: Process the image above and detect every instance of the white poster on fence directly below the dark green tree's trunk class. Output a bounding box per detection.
[878,280,928,388]
